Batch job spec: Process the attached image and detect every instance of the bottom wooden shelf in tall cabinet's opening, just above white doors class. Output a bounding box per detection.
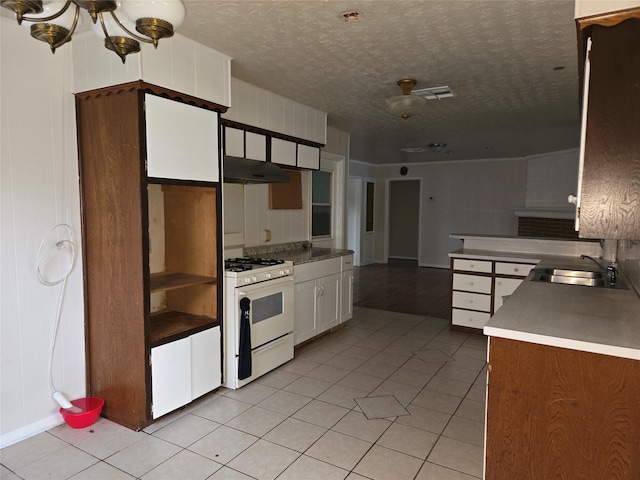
[149,310,220,347]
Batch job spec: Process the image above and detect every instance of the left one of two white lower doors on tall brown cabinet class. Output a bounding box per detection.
[151,338,191,418]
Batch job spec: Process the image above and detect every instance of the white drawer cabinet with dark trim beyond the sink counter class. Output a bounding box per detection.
[451,257,535,332]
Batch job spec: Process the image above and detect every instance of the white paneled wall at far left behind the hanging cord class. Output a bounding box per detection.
[0,17,85,446]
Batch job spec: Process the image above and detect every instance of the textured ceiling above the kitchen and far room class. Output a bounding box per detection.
[179,0,579,164]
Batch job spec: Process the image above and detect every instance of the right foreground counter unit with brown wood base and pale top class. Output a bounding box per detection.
[484,256,640,480]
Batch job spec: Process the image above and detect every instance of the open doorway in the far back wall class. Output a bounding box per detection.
[386,179,421,265]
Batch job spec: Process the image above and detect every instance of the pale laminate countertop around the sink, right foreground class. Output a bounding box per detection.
[484,252,640,360]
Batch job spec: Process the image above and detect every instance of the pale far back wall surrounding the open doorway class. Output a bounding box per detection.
[372,158,527,268]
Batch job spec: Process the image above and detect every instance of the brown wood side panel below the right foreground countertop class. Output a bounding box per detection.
[485,337,640,480]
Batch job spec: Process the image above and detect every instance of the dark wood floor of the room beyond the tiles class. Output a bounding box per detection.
[353,260,451,319]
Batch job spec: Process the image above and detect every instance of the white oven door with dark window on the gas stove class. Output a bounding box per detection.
[233,277,294,355]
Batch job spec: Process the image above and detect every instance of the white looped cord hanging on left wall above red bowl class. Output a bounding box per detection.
[36,223,82,413]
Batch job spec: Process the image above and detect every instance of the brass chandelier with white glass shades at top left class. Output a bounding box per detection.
[1,0,186,63]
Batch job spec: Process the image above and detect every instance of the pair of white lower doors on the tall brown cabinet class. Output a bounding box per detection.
[151,327,222,418]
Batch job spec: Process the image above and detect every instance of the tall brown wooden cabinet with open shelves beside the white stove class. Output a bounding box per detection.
[76,82,224,429]
